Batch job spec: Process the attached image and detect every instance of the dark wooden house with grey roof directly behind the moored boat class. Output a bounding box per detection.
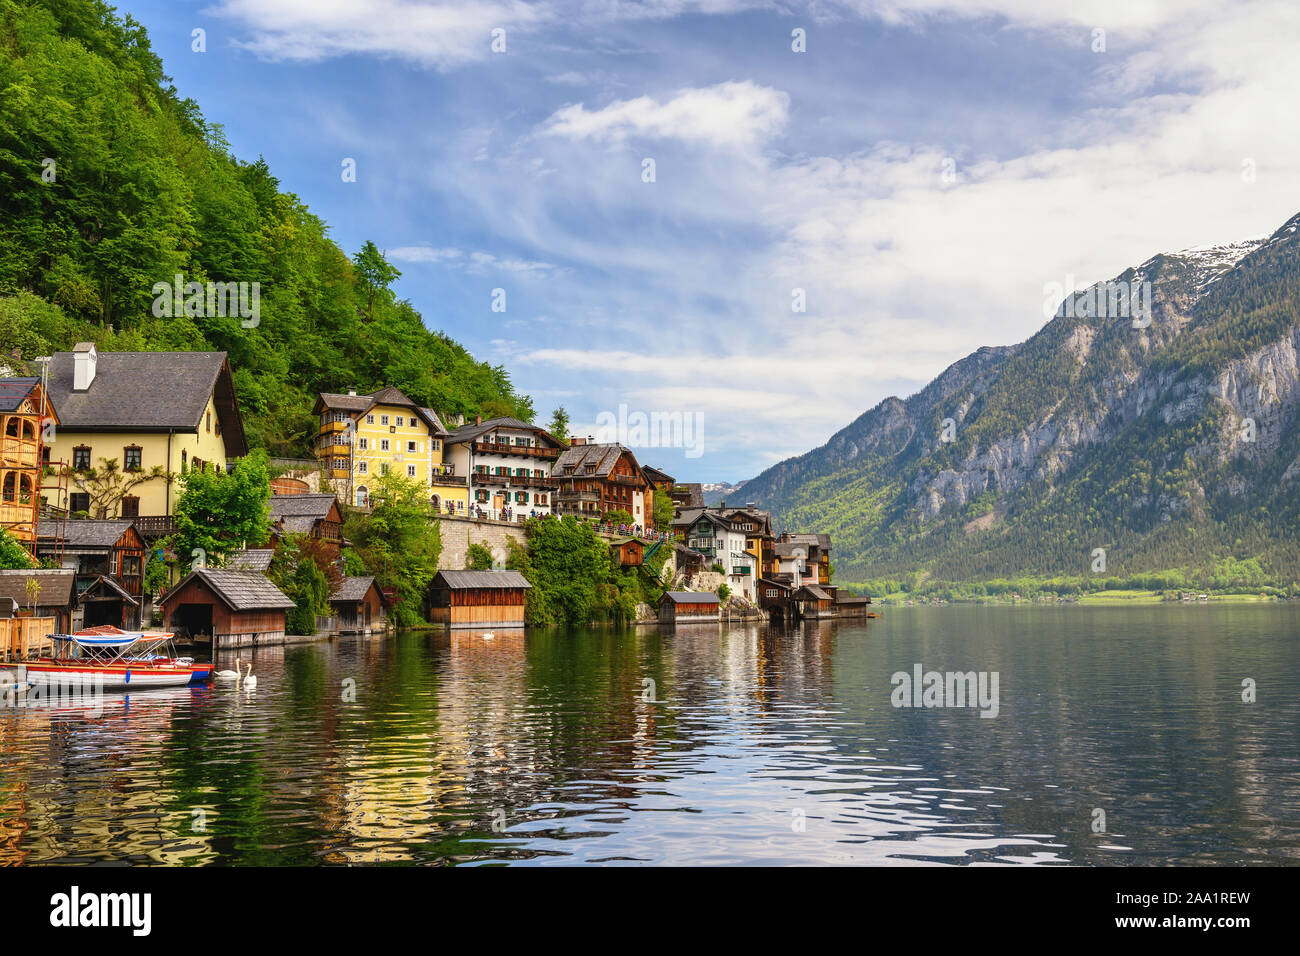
[36,519,148,628]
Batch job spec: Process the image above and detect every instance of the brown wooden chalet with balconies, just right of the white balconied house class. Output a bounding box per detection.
[551,438,654,528]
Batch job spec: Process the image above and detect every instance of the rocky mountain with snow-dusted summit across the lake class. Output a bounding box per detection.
[744,216,1300,584]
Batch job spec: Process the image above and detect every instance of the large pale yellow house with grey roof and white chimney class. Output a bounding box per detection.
[36,342,248,538]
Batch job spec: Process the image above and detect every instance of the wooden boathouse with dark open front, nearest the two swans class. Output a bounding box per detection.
[159,568,294,650]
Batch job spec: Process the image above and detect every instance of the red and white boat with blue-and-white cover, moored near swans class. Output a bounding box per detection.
[21,624,213,692]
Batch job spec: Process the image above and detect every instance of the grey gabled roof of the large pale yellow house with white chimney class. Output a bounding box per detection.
[39,350,248,458]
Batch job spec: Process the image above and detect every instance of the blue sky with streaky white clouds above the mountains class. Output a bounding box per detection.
[118,0,1300,481]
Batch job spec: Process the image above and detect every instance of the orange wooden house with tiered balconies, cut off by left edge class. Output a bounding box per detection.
[0,377,59,551]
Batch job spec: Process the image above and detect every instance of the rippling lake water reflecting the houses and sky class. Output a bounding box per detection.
[0,605,1300,865]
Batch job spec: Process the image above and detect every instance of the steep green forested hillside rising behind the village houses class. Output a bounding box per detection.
[0,0,533,455]
